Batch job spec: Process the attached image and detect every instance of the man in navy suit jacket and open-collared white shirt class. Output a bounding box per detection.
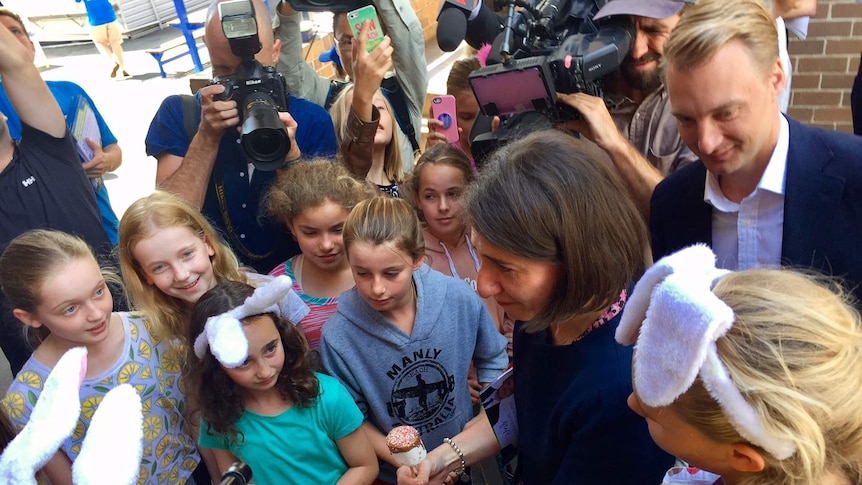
[650,0,862,298]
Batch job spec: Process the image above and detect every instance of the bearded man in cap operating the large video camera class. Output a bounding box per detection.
[558,0,697,218]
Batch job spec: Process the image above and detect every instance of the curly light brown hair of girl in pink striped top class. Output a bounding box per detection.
[265,159,376,229]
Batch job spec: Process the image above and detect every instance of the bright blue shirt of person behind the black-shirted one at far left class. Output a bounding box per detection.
[0,81,119,245]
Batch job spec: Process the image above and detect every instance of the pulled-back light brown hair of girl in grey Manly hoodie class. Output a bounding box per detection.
[342,196,425,261]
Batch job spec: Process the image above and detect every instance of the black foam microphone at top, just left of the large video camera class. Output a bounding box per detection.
[437,0,503,52]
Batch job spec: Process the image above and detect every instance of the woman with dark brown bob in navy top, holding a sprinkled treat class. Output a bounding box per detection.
[399,131,673,485]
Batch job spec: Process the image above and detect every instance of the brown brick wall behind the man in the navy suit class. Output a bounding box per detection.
[788,0,862,133]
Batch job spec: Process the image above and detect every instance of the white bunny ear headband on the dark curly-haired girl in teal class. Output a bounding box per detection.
[195,276,293,369]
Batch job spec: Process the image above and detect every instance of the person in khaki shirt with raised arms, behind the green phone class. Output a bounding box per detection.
[275,0,428,172]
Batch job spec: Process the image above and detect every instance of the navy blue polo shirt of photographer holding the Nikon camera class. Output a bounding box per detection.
[145,91,336,274]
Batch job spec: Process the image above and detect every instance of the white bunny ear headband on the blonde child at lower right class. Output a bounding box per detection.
[616,245,796,460]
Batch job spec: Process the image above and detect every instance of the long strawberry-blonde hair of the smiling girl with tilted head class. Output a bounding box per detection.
[117,190,248,339]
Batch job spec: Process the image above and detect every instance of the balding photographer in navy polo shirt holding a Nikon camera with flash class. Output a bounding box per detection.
[146,0,335,273]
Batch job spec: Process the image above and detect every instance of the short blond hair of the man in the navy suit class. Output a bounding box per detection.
[661,0,778,75]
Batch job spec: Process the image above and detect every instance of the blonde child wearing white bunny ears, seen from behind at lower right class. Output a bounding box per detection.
[616,246,862,485]
